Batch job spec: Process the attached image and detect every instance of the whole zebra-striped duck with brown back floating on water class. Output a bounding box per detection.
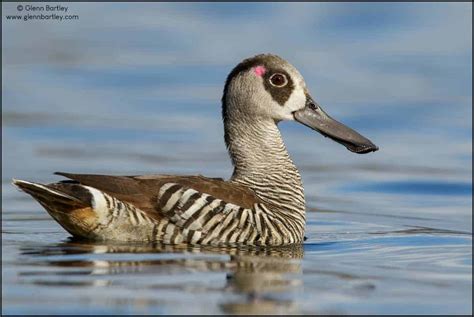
[13,54,378,246]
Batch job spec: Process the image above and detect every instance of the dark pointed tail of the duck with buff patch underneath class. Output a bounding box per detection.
[12,179,97,237]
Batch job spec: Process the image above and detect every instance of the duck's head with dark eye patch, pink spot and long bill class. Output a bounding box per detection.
[222,54,378,153]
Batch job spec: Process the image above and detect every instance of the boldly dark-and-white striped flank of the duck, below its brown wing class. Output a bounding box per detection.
[123,183,304,245]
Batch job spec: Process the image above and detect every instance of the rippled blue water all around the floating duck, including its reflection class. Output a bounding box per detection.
[2,3,472,314]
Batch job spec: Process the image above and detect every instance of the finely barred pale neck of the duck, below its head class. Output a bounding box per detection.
[224,116,305,217]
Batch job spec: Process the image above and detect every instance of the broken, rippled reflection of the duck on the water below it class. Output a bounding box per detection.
[20,239,303,314]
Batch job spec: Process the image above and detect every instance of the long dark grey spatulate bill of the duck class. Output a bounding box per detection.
[293,96,379,154]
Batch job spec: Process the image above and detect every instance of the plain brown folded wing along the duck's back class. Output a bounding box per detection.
[55,172,261,212]
